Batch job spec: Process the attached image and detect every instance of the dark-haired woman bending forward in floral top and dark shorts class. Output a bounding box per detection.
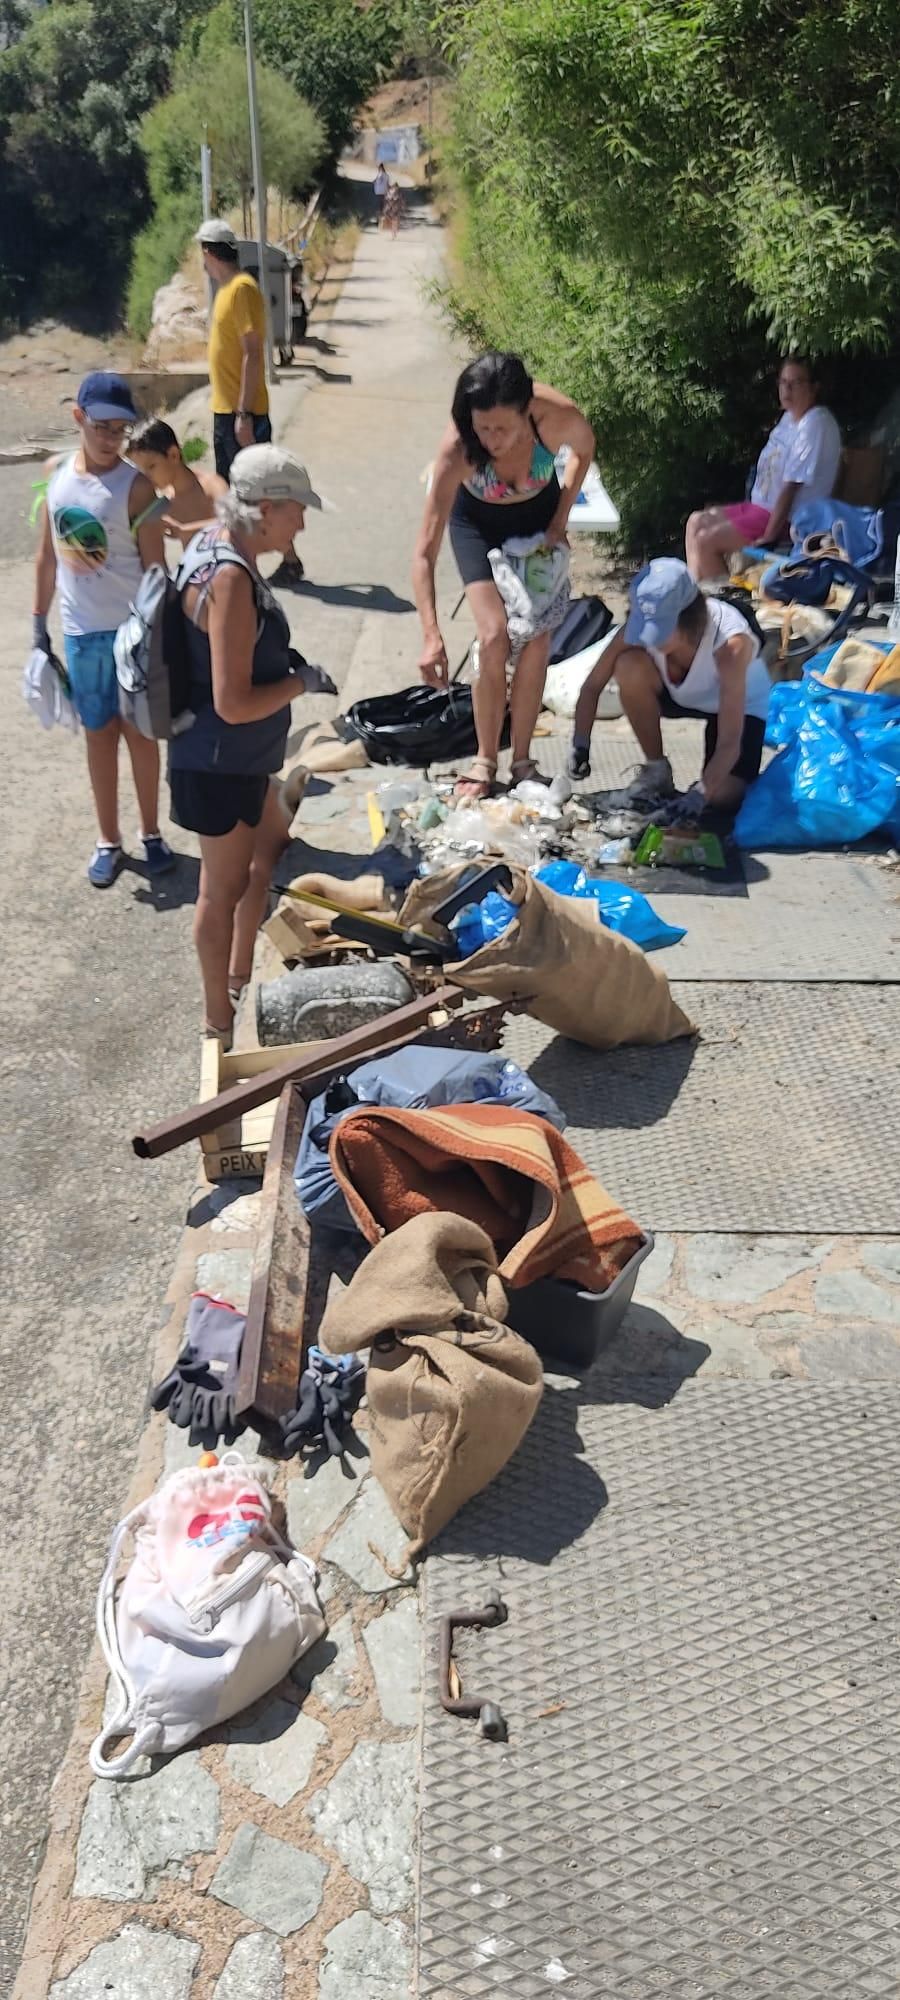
[412,354,594,798]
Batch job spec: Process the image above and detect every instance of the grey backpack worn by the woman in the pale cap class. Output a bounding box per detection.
[114,562,194,742]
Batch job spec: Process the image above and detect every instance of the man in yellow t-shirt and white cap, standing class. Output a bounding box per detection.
[196,216,272,480]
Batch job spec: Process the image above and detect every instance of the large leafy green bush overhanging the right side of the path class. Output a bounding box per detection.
[438,0,900,544]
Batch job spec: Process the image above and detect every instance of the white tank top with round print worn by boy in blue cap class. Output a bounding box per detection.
[46,458,142,634]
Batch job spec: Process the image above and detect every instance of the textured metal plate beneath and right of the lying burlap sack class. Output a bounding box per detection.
[504,980,900,1236]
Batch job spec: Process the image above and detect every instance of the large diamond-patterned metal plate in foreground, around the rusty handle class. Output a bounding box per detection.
[416,1378,900,2000]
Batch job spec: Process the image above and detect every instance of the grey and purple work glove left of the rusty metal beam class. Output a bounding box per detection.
[150,1292,246,1450]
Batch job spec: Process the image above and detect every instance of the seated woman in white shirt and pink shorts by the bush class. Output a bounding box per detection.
[684,356,840,582]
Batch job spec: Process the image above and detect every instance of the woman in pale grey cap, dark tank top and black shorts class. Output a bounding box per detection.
[168,444,334,1046]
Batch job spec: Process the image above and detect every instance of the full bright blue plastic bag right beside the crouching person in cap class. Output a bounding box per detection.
[734,676,900,848]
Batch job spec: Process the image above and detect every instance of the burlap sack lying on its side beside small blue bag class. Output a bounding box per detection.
[400,866,694,1048]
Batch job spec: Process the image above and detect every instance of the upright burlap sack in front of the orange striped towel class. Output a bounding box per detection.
[318,1216,544,1556]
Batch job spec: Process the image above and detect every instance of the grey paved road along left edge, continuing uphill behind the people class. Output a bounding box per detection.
[0,203,464,1990]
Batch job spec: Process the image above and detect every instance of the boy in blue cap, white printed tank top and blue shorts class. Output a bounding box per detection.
[34,372,174,888]
